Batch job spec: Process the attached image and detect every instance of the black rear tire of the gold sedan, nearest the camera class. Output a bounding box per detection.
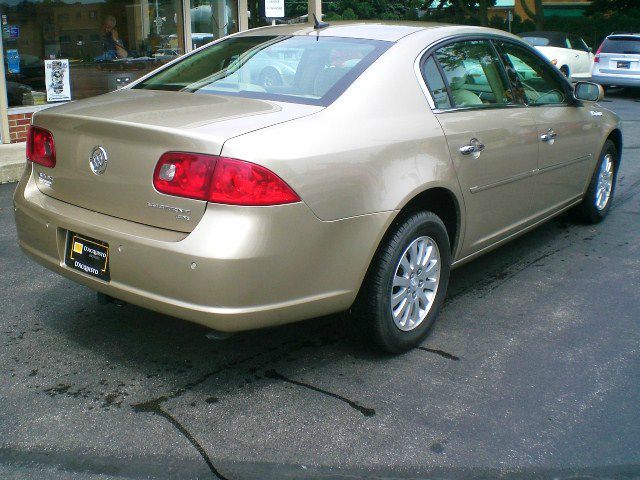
[353,212,451,353]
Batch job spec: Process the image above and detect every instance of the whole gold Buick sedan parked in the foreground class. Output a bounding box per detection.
[14,23,622,352]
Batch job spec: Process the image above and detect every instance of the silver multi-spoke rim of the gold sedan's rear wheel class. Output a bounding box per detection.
[391,236,441,332]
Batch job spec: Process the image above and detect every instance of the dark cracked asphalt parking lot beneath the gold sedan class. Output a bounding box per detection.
[0,91,640,480]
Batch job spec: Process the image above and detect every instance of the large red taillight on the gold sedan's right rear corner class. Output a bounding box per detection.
[153,152,300,206]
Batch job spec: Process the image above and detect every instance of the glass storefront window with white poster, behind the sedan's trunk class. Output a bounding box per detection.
[0,0,188,107]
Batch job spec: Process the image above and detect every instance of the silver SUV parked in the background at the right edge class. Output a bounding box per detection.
[591,33,640,87]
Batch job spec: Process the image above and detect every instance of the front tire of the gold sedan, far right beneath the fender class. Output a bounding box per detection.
[576,140,618,223]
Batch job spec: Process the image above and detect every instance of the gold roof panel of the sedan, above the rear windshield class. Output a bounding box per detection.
[236,21,512,42]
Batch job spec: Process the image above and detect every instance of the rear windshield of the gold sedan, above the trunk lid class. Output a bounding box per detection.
[133,35,392,106]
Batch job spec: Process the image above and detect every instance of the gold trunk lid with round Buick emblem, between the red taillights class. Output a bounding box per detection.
[34,90,321,232]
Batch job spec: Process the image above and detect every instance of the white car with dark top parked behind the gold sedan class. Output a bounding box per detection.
[519,32,594,80]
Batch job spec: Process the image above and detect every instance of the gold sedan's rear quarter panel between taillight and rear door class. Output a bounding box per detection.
[222,34,461,220]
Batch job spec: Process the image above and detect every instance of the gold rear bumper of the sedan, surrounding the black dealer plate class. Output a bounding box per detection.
[14,168,392,332]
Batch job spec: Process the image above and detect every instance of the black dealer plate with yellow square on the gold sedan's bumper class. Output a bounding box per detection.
[64,232,111,282]
